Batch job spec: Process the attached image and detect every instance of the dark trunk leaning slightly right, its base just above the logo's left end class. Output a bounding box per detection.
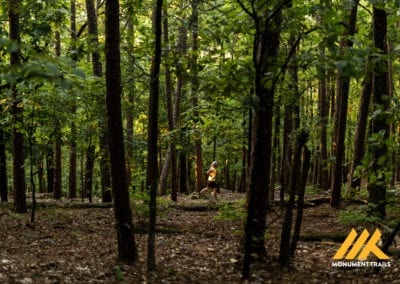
[331,0,359,208]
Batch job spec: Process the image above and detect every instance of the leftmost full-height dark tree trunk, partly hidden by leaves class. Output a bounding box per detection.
[8,0,27,213]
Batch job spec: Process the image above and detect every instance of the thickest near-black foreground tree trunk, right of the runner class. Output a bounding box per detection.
[242,5,282,279]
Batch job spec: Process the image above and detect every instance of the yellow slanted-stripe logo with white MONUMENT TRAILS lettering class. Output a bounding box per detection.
[332,228,390,267]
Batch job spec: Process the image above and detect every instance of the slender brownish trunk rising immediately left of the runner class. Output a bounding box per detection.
[190,0,203,192]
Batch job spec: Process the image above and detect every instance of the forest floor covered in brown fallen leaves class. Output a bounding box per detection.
[0,191,400,284]
